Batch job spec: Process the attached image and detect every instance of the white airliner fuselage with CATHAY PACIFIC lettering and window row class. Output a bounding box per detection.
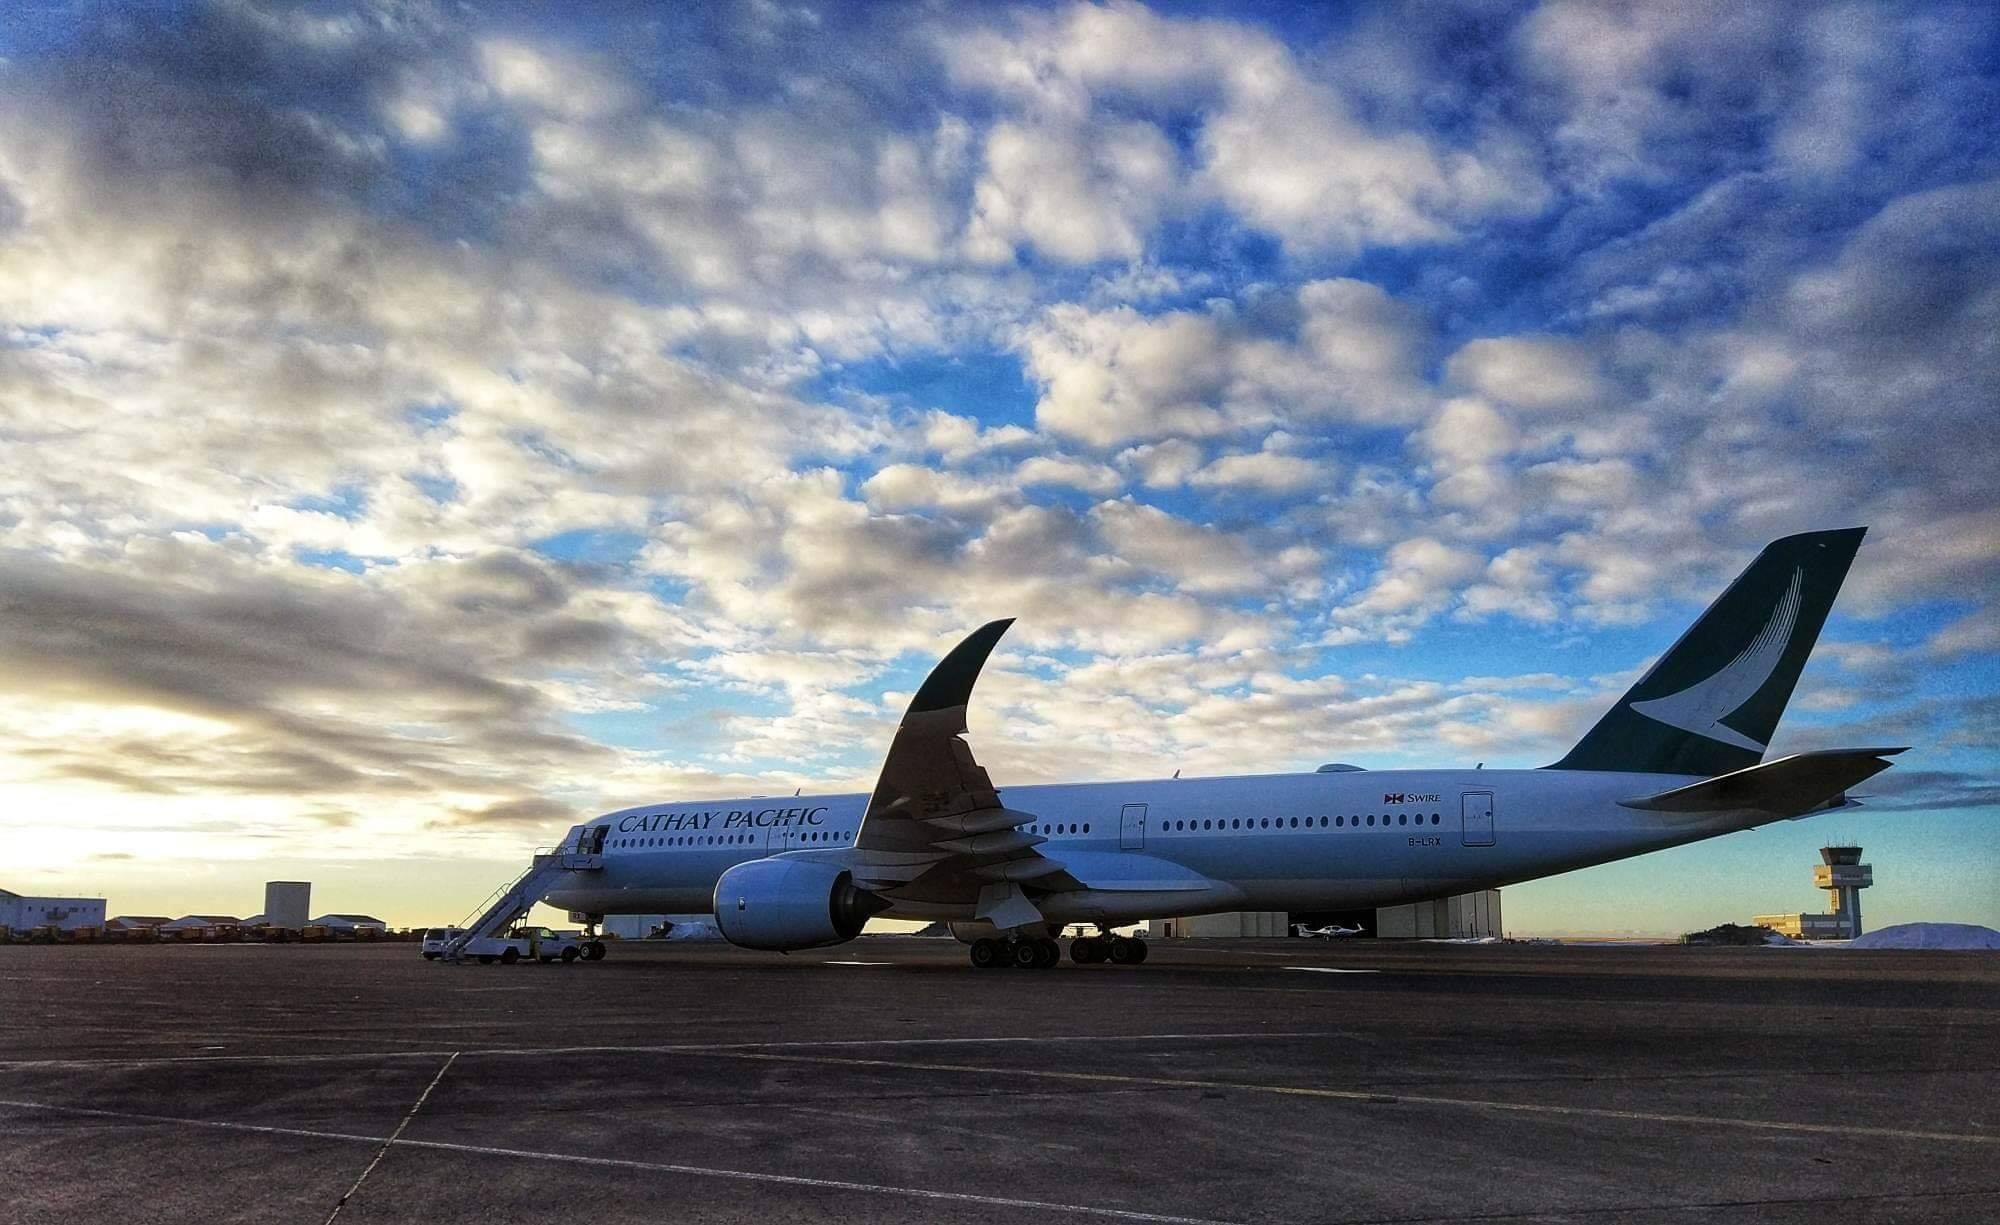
[548,771,1728,923]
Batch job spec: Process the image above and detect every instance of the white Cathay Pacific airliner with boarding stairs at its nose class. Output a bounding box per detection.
[460,528,1902,969]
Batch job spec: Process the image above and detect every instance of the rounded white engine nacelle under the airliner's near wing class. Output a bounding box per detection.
[714,859,888,953]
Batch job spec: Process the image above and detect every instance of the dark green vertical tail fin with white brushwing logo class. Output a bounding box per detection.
[1548,528,1868,777]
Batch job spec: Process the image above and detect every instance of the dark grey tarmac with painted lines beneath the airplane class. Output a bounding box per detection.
[0,937,2000,1225]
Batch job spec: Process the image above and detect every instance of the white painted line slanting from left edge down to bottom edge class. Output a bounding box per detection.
[0,1096,1236,1225]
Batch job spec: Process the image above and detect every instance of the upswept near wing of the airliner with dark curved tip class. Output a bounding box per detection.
[848,619,1082,927]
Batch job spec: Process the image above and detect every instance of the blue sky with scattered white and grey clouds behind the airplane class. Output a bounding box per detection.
[0,0,2000,931]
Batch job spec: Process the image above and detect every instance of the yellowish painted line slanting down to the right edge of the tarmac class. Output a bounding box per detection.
[692,1051,2000,1145]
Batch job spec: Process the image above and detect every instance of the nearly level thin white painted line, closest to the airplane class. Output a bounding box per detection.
[0,1029,1352,1073]
